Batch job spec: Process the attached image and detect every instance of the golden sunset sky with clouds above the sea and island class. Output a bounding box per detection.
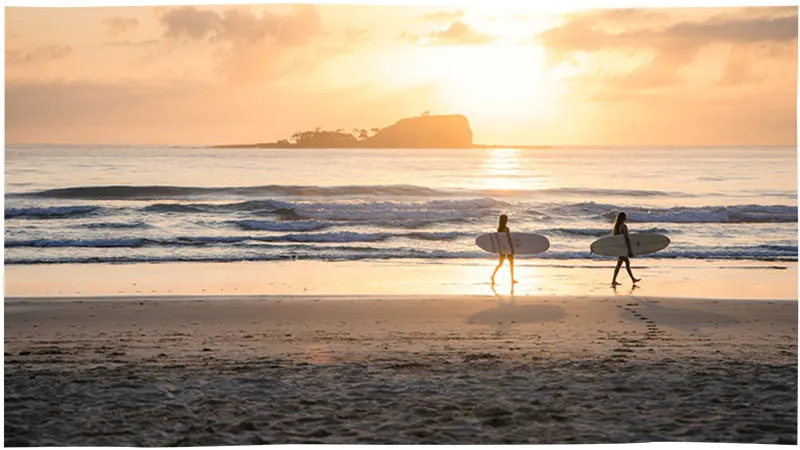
[5,0,798,146]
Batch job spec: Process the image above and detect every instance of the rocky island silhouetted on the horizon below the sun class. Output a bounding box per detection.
[212,111,548,149]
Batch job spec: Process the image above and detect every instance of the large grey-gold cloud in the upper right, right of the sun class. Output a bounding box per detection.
[539,8,797,89]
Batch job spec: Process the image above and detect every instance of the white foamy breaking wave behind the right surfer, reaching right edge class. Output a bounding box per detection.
[553,202,797,223]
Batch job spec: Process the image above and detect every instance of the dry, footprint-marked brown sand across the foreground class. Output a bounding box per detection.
[5,295,797,446]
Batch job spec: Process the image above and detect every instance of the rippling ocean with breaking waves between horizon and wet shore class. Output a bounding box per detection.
[4,145,798,267]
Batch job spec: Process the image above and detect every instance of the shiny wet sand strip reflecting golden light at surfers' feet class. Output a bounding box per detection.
[5,259,798,301]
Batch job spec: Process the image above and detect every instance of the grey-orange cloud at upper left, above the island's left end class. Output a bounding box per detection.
[159,5,325,84]
